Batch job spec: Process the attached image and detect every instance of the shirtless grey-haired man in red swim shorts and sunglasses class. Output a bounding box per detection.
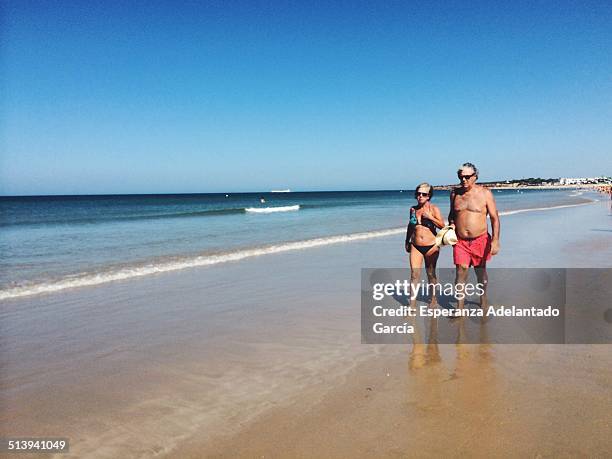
[448,163,499,309]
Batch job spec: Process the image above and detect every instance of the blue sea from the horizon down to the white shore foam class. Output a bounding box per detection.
[0,189,596,300]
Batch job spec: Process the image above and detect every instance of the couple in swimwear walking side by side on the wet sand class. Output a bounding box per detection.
[406,163,500,308]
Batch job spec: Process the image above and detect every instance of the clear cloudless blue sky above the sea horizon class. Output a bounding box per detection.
[0,0,612,194]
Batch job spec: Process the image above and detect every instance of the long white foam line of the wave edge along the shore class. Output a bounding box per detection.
[0,201,594,301]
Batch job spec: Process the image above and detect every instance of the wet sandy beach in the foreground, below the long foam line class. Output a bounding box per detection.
[0,201,612,457]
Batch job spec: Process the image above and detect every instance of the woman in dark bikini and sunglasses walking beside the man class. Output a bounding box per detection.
[406,182,444,304]
